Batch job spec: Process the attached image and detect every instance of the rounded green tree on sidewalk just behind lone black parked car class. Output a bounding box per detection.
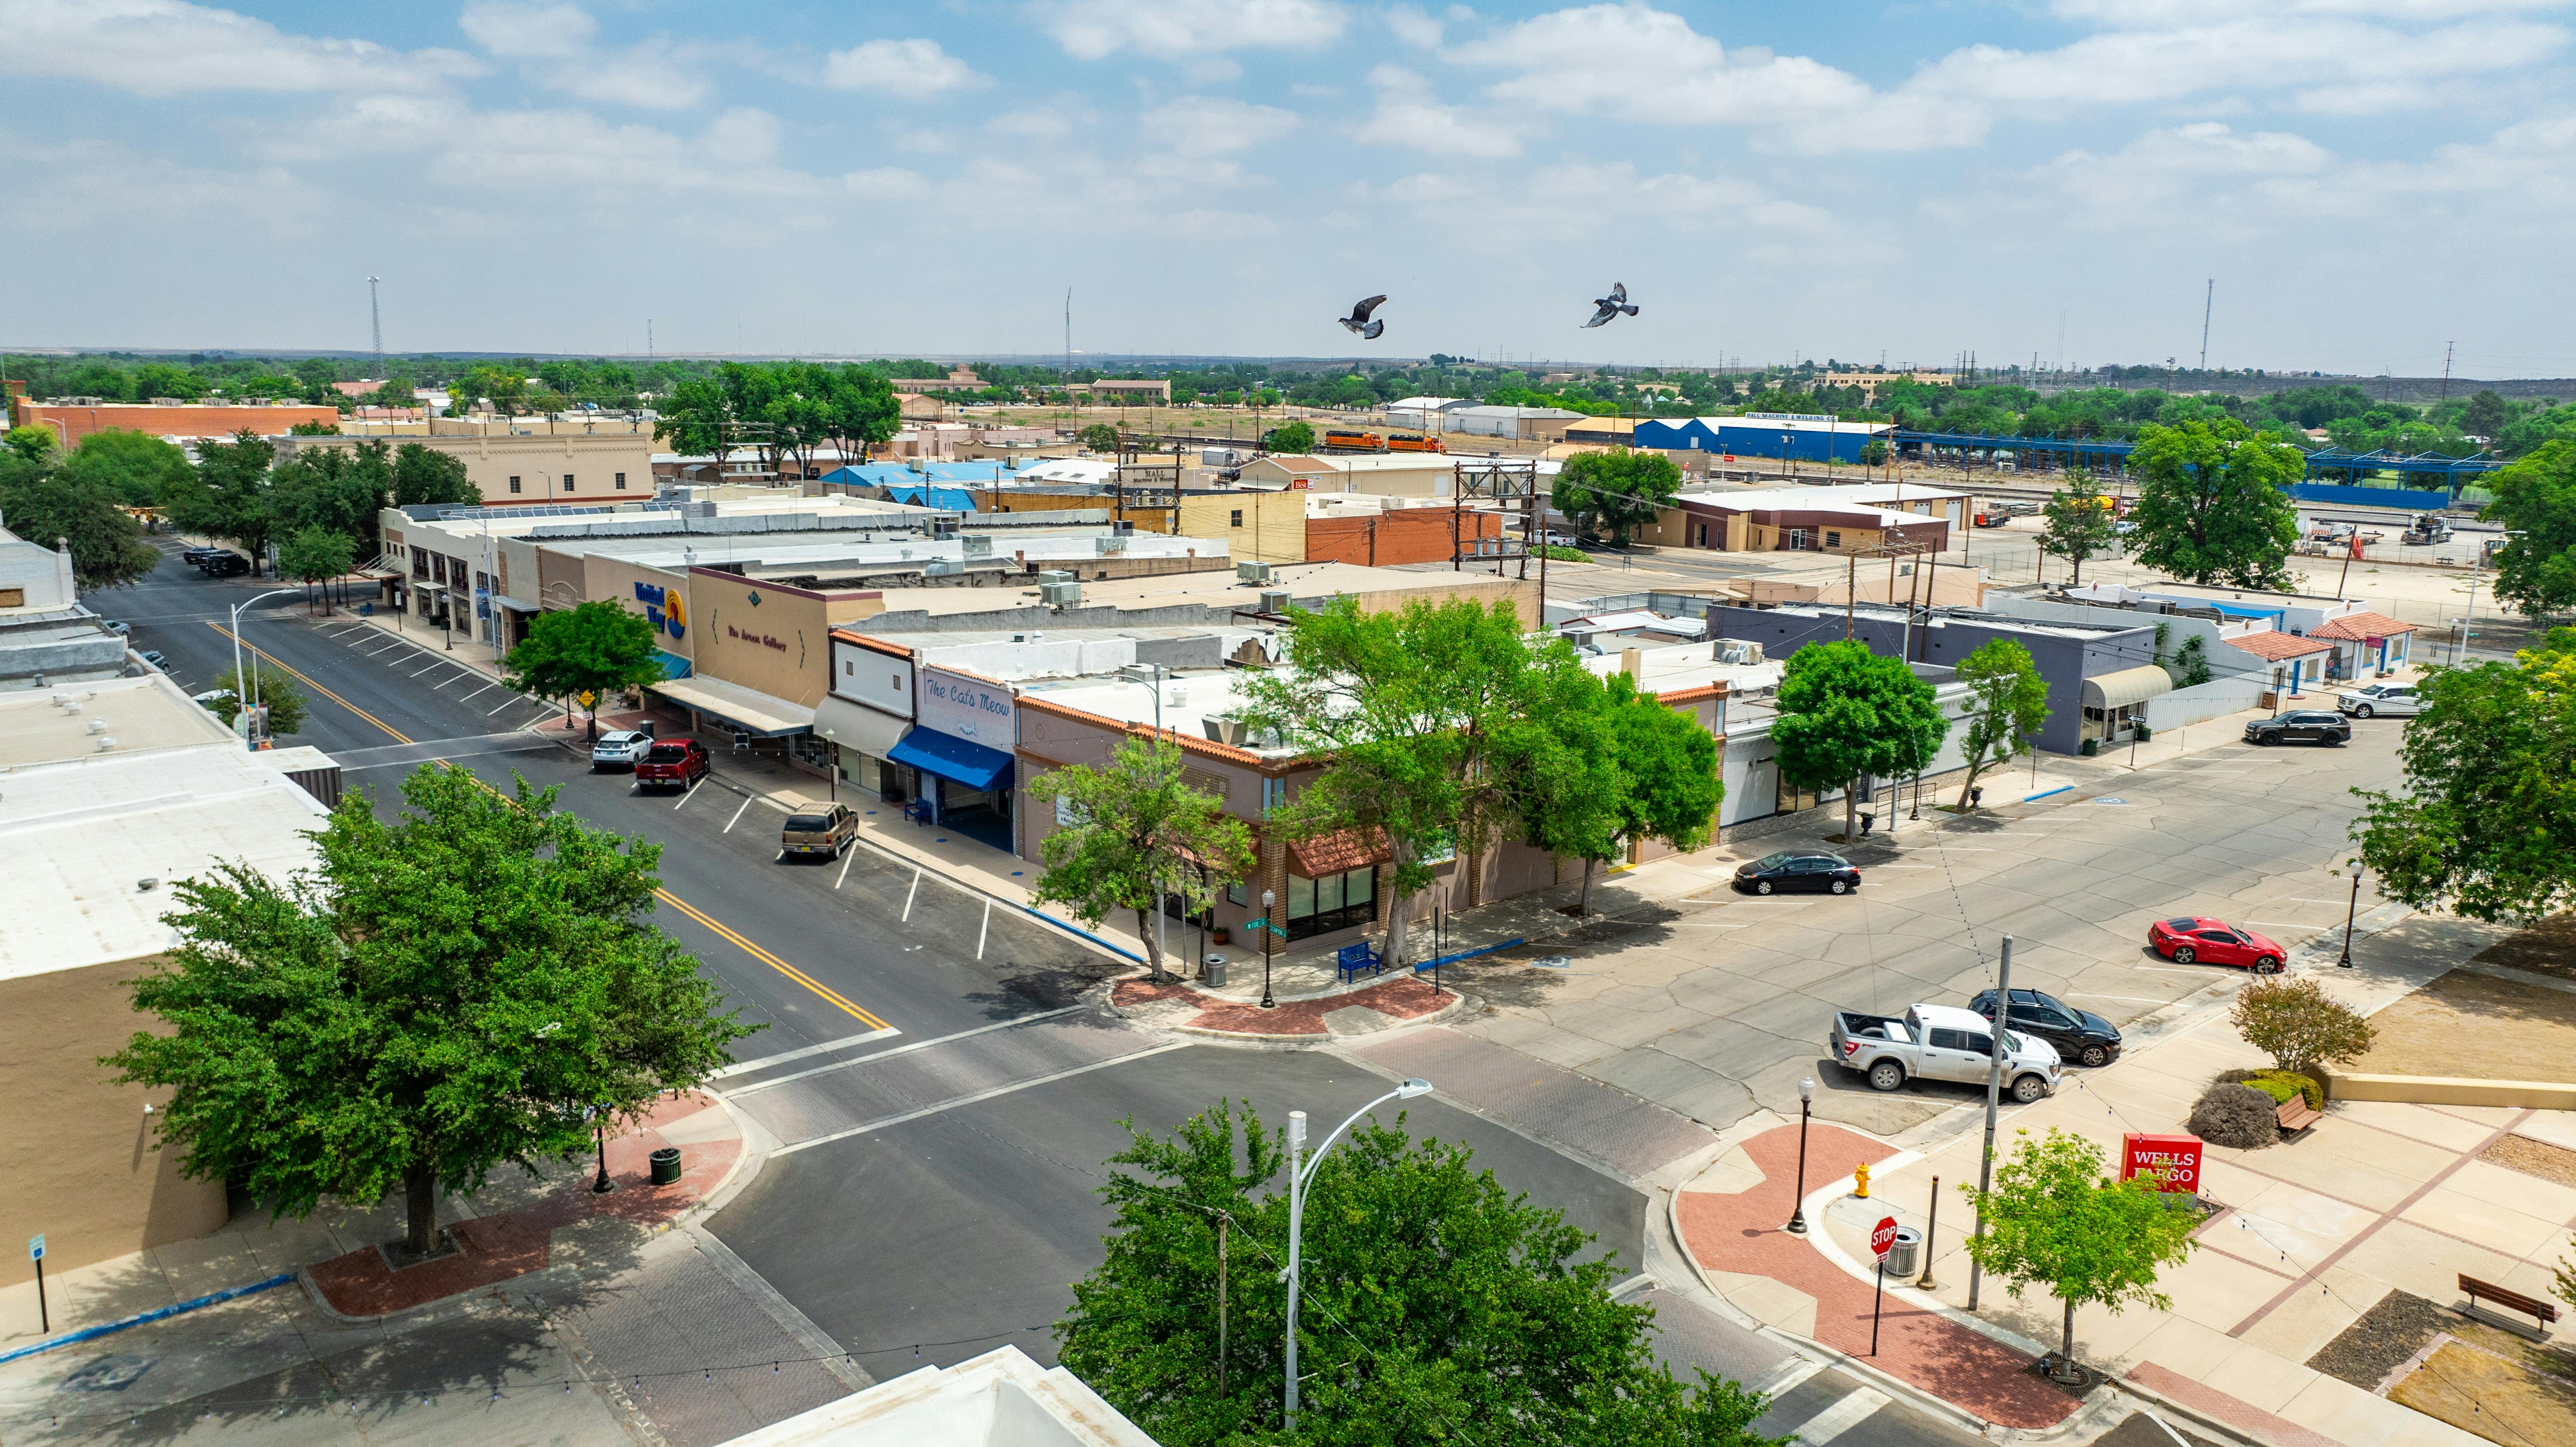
[1772,638,1950,842]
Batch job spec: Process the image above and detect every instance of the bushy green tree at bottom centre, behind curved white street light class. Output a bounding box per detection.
[1056,1102,1782,1447]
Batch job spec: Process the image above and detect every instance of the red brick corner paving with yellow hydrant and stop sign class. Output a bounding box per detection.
[1674,1125,2079,1426]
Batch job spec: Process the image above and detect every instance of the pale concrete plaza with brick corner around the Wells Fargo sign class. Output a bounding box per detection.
[1674,909,2545,1447]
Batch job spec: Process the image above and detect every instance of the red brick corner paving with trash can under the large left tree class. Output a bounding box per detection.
[306,1094,742,1316]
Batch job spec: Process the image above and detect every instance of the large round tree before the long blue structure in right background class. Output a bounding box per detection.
[2128,417,2308,592]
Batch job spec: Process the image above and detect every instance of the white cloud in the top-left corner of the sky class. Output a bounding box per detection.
[0,0,482,95]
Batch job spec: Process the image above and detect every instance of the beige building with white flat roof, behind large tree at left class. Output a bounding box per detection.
[0,672,324,1267]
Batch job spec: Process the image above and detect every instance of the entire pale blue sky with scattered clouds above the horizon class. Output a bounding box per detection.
[0,0,2576,376]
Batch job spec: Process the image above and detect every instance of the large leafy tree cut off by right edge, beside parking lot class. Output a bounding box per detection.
[2352,628,2576,919]
